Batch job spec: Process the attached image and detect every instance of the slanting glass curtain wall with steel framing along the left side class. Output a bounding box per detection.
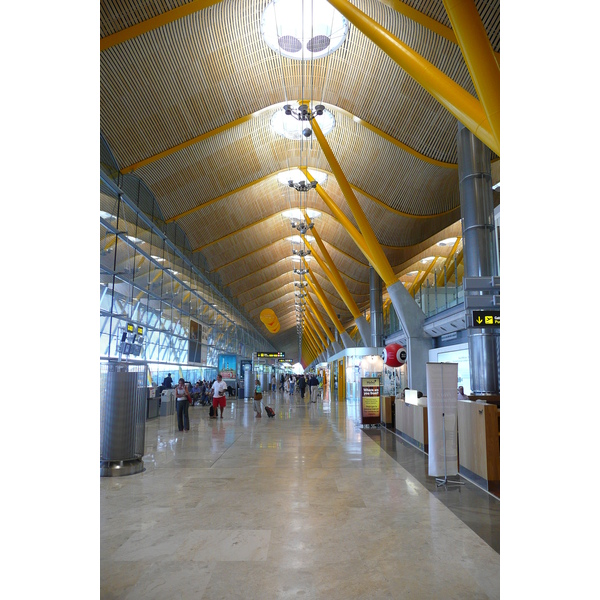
[100,136,275,383]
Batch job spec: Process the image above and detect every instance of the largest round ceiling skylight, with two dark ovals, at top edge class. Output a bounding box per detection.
[260,0,348,60]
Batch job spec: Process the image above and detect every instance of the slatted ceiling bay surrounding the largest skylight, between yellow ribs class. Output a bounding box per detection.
[101,0,482,170]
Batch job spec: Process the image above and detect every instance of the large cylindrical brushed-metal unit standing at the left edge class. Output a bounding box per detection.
[100,363,147,477]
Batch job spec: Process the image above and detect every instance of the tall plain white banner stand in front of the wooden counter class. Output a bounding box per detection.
[426,363,458,477]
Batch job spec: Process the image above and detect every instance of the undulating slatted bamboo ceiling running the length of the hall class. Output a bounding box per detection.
[100,0,500,356]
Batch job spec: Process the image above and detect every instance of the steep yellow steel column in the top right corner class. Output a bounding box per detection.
[444,0,500,154]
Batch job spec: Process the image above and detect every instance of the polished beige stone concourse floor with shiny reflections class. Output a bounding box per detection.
[100,392,500,600]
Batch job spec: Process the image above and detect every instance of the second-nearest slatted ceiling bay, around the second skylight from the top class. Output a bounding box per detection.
[117,110,458,245]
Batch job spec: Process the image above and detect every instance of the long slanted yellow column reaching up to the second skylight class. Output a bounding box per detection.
[311,119,397,286]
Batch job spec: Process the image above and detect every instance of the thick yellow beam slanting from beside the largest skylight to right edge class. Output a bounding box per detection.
[328,0,500,155]
